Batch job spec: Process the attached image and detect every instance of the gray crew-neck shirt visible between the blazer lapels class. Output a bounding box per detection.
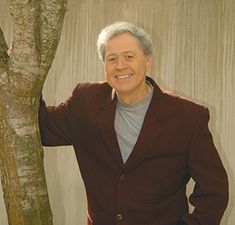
[114,84,153,163]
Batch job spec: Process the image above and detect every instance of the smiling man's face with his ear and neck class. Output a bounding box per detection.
[104,33,152,101]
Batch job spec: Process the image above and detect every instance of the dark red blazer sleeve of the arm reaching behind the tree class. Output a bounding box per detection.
[38,90,76,146]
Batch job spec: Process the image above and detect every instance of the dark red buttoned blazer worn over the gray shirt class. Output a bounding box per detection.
[39,78,228,225]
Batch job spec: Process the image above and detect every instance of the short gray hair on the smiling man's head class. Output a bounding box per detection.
[97,21,153,61]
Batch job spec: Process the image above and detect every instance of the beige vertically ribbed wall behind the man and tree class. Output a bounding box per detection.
[0,0,235,225]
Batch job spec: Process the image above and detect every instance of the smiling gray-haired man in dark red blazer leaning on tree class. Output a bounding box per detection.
[39,22,228,225]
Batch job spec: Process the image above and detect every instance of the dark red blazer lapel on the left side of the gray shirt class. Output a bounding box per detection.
[97,90,123,167]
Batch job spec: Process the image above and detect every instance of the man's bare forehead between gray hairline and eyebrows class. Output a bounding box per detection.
[105,33,143,54]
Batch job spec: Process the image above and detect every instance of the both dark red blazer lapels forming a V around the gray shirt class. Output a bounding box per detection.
[97,78,165,168]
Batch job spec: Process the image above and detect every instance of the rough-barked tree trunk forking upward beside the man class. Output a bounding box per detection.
[0,0,66,225]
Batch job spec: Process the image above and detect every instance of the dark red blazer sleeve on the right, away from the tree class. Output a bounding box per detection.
[182,109,228,225]
